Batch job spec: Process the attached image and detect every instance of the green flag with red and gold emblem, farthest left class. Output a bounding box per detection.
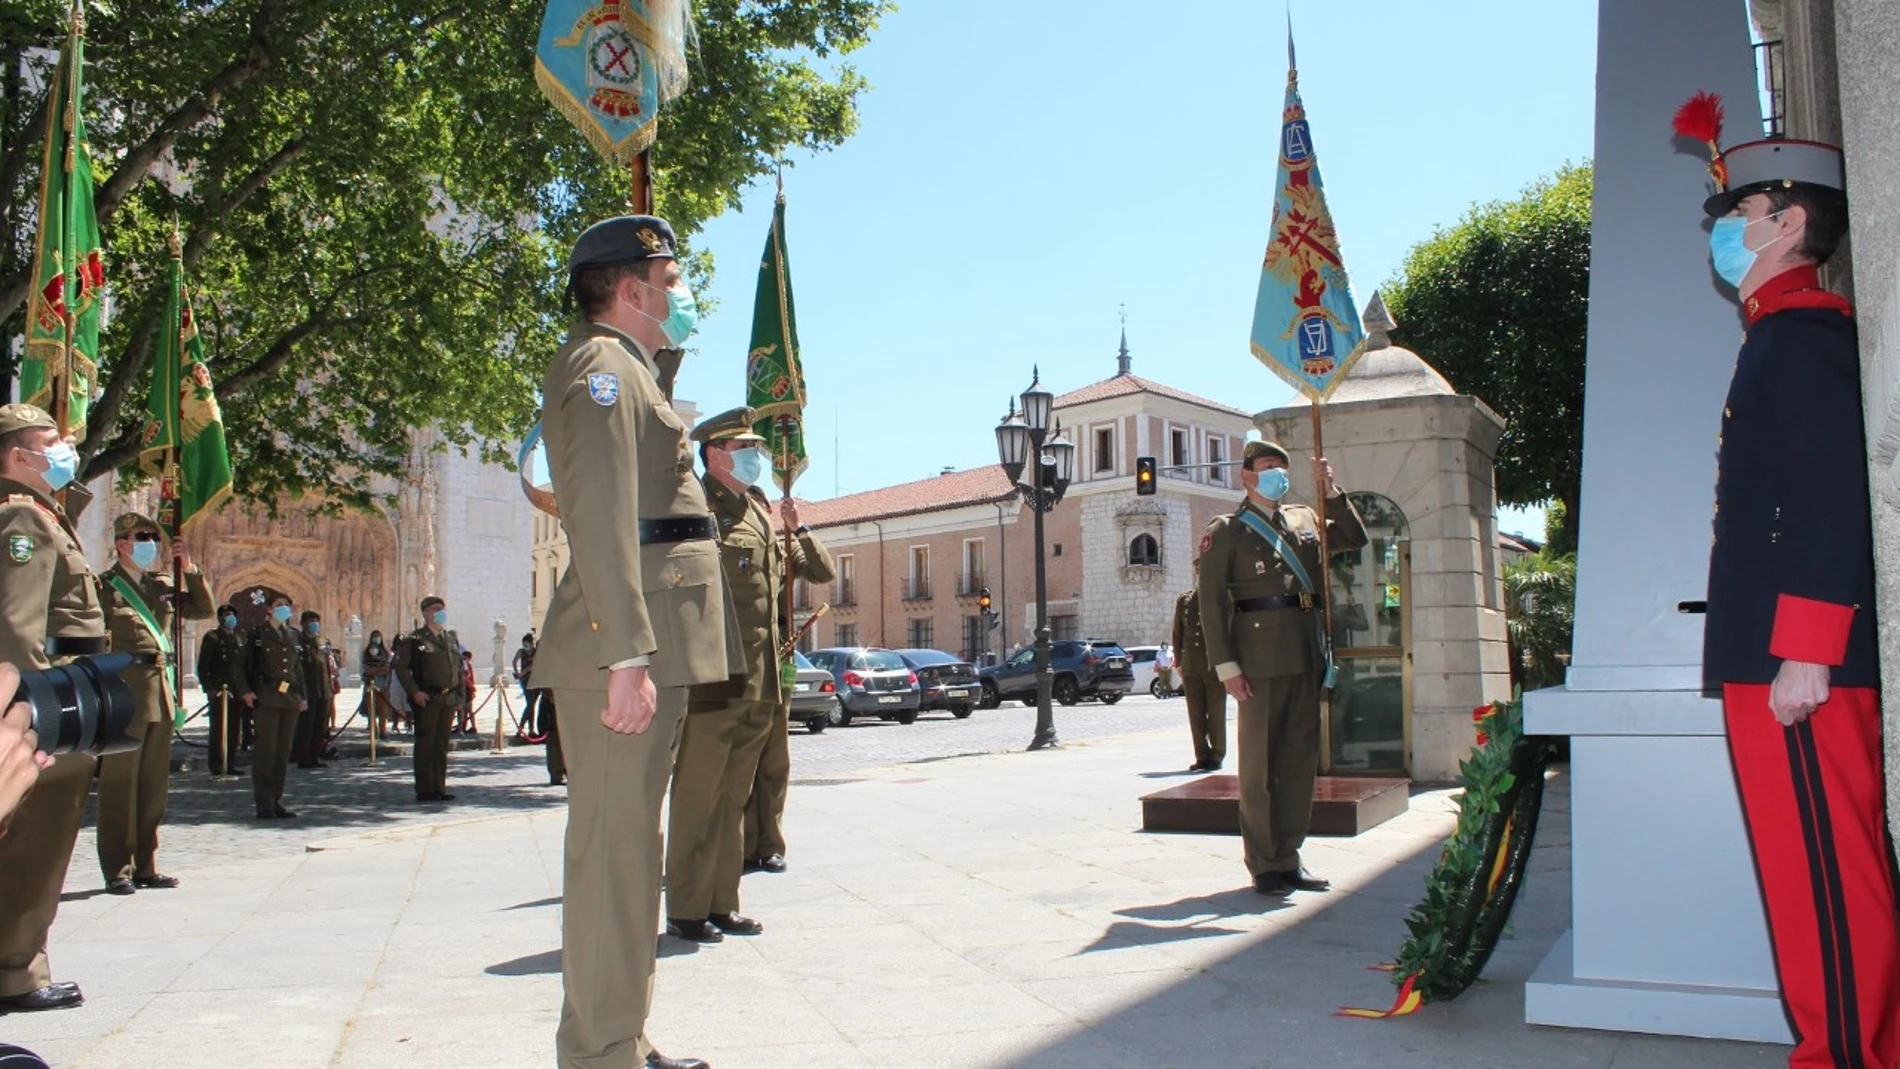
[19,4,106,439]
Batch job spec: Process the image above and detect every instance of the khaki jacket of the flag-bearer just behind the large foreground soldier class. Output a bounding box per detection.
[688,477,834,712]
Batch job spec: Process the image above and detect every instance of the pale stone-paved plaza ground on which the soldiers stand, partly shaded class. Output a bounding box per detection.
[11,697,1786,1069]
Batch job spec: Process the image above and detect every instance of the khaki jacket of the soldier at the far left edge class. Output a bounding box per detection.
[0,478,106,672]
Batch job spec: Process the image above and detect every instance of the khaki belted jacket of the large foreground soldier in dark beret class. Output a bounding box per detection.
[534,323,745,691]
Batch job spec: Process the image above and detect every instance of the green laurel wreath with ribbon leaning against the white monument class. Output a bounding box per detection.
[1393,699,1556,1003]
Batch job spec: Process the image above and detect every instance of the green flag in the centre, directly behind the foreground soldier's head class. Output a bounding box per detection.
[745,194,806,494]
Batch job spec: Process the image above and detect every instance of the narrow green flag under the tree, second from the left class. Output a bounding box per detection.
[139,234,232,534]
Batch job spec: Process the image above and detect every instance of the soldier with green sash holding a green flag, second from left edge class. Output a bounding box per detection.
[99,513,217,894]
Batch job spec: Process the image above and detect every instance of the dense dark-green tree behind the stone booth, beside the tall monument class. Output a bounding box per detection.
[1379,163,1590,545]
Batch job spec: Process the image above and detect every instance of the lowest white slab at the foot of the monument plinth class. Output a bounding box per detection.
[1524,932,1794,1044]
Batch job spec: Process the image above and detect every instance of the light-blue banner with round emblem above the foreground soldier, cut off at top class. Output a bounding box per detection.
[534,0,690,163]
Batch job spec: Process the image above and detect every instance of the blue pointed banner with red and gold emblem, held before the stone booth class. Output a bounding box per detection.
[1252,30,1366,401]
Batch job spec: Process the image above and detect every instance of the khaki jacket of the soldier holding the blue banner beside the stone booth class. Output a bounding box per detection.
[1199,494,1366,680]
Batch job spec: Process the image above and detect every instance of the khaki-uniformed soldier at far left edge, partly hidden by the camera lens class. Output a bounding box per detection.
[0,404,106,1014]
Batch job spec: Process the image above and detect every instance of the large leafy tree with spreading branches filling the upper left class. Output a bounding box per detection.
[0,0,889,505]
